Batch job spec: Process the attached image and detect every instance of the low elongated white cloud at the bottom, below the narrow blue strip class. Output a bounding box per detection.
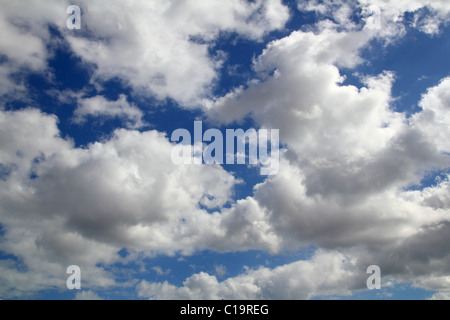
[137,251,358,300]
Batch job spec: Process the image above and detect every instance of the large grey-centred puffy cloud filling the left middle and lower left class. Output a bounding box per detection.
[0,109,278,297]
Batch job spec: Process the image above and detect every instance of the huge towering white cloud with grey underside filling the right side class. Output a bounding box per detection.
[206,12,450,296]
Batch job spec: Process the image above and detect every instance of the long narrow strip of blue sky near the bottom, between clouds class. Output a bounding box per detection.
[94,246,317,289]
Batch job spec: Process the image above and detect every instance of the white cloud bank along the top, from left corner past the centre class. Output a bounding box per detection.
[0,0,289,105]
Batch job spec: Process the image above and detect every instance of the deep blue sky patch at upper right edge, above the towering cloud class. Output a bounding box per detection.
[341,24,450,116]
